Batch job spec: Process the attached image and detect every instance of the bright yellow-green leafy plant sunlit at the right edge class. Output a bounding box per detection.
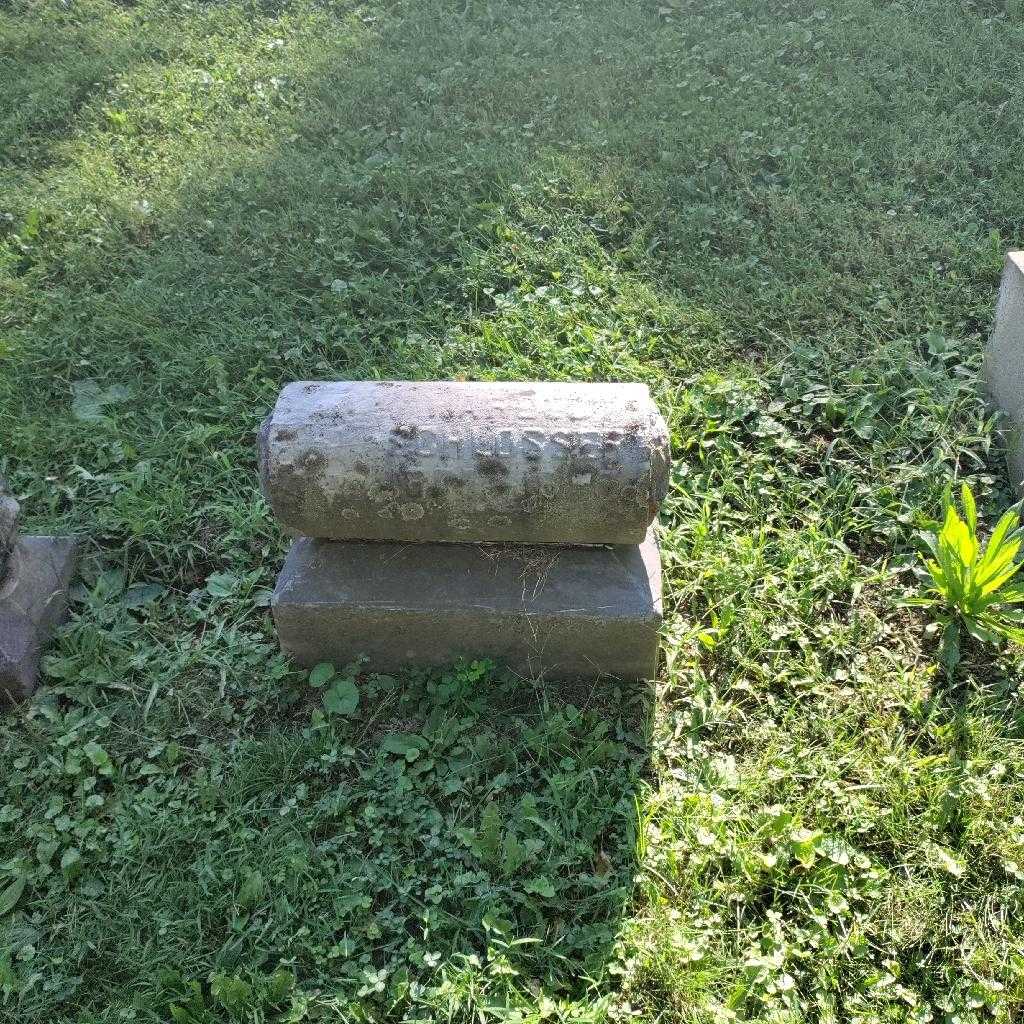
[907,483,1024,677]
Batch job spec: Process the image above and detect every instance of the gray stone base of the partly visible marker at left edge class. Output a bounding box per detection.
[0,537,75,703]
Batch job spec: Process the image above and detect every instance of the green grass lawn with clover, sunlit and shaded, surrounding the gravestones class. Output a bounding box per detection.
[0,0,1024,1024]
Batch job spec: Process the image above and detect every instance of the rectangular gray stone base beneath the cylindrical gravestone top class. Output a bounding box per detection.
[271,535,662,679]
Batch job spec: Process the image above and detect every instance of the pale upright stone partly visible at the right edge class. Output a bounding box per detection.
[985,252,1024,495]
